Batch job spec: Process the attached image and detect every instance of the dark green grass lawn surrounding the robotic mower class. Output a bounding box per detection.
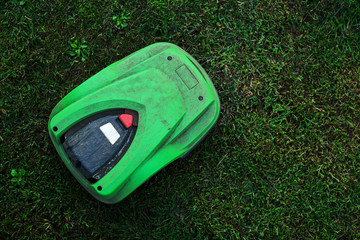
[0,0,360,239]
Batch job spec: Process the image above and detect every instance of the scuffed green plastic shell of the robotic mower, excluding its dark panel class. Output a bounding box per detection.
[48,43,220,204]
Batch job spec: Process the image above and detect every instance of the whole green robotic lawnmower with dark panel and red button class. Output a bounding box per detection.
[48,43,220,203]
